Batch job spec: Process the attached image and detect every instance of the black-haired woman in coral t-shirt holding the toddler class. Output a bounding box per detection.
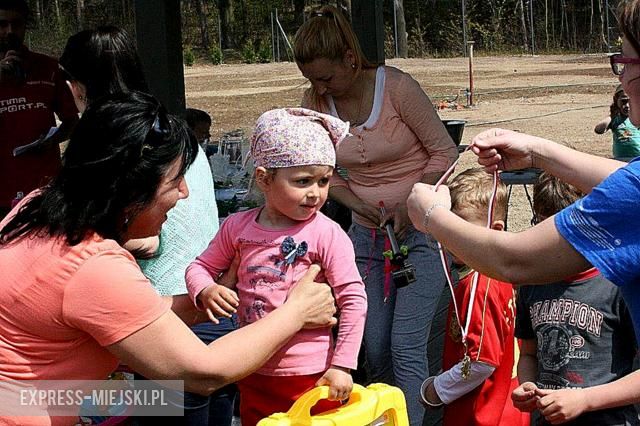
[0,92,335,424]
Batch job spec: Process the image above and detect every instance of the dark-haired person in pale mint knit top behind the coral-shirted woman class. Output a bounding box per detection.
[60,26,237,426]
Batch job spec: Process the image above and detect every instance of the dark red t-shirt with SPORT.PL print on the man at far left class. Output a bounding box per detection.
[0,49,78,208]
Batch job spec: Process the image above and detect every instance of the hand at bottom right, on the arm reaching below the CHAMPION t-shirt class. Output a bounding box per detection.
[536,389,588,425]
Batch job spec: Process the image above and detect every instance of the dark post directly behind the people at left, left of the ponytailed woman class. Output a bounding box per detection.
[135,0,185,115]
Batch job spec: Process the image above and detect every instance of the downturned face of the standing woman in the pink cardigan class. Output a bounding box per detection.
[298,51,355,98]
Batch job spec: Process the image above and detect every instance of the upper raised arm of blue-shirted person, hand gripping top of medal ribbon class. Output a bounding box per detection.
[472,129,625,193]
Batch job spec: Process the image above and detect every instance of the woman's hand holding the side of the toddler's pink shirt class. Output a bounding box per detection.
[283,265,338,328]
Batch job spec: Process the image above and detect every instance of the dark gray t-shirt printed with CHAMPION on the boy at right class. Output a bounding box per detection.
[516,269,640,425]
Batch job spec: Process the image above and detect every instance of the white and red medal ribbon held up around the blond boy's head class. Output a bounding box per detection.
[434,144,498,379]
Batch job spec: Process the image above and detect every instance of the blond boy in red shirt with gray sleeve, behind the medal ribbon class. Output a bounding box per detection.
[421,168,529,426]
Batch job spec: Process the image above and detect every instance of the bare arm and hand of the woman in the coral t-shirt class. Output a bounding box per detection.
[107,265,336,394]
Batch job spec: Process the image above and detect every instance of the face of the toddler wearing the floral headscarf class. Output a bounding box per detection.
[256,166,333,227]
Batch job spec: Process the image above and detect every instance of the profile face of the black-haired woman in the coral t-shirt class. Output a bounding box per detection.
[126,158,189,240]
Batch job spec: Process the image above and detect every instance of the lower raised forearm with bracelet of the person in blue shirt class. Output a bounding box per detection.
[407,183,591,284]
